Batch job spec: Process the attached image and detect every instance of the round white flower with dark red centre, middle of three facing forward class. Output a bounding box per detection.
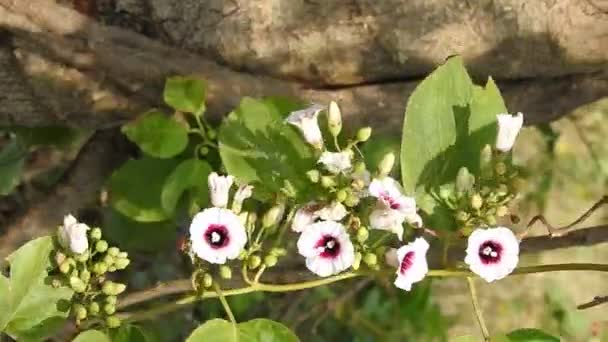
[298,221,355,277]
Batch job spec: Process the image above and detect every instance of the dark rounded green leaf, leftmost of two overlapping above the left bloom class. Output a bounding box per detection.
[109,157,179,222]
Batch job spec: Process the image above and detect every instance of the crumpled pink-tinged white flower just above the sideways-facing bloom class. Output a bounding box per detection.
[369,177,422,240]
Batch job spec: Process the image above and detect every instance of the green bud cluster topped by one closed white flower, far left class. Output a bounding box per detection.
[53,215,130,328]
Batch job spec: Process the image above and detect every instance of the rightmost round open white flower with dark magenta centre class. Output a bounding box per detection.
[464,227,519,282]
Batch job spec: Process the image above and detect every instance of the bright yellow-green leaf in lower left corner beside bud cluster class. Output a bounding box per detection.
[0,237,73,341]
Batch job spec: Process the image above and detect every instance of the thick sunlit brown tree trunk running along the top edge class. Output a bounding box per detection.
[142,0,608,85]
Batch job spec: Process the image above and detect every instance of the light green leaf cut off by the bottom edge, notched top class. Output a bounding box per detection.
[186,318,299,342]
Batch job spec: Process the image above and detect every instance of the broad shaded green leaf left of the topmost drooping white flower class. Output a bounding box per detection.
[219,97,315,197]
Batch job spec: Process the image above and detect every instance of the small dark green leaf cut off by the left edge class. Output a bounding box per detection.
[0,138,27,195]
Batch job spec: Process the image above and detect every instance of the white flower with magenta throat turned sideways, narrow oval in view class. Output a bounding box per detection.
[395,238,429,291]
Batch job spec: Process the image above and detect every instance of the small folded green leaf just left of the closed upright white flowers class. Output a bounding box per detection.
[161,159,211,215]
